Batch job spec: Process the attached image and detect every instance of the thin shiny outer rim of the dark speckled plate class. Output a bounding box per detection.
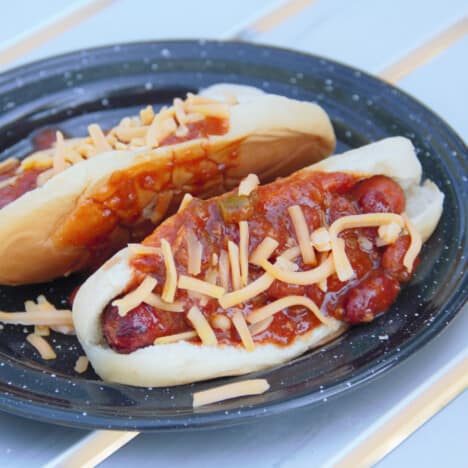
[0,40,468,431]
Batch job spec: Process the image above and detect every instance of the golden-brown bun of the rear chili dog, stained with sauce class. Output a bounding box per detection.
[0,85,335,285]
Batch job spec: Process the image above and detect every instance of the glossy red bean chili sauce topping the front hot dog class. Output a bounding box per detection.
[103,172,411,352]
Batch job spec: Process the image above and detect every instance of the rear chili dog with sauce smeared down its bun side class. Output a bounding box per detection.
[0,85,335,285]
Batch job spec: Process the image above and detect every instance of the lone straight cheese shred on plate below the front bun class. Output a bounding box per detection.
[193,379,270,408]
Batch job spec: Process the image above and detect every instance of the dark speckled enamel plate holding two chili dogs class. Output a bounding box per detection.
[0,41,468,430]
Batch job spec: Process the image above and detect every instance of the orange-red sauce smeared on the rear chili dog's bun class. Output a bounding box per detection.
[54,118,230,252]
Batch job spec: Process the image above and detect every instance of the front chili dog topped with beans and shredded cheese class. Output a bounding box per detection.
[73,137,444,386]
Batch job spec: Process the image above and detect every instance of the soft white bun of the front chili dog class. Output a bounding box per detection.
[73,137,444,386]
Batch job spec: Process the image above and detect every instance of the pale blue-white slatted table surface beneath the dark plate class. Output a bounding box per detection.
[0,0,468,468]
